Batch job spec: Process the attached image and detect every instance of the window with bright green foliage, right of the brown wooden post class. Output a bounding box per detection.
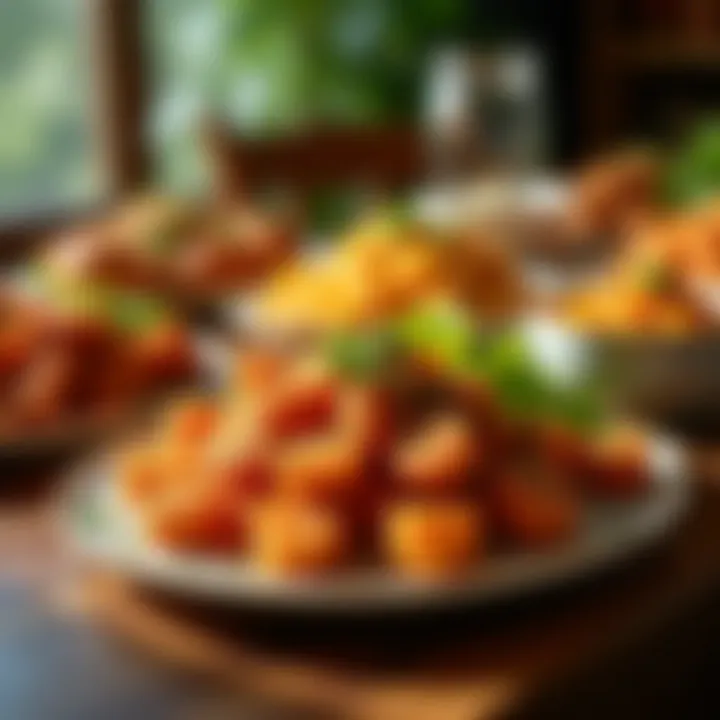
[145,0,464,191]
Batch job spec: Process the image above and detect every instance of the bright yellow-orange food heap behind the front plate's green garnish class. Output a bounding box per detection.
[260,212,523,329]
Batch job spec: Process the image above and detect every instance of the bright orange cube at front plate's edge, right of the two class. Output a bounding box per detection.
[382,501,485,579]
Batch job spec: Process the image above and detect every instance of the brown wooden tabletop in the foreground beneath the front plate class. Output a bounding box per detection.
[0,452,720,720]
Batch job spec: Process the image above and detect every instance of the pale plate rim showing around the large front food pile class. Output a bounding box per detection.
[63,439,688,613]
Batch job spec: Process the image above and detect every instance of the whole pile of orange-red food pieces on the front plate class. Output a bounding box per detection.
[119,350,648,579]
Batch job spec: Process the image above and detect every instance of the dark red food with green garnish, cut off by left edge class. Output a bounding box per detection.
[0,286,227,459]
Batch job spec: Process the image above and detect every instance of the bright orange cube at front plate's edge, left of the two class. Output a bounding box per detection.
[249,500,350,576]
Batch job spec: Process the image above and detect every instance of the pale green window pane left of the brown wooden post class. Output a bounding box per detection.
[0,0,101,219]
